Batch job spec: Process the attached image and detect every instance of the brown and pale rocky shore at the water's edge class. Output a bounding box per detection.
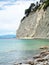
[14,46,49,65]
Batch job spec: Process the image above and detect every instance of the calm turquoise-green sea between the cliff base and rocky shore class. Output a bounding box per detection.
[0,39,49,65]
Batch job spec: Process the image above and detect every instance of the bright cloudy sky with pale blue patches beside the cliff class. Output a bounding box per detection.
[0,0,39,35]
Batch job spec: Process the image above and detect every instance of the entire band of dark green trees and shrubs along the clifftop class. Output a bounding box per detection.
[21,0,49,22]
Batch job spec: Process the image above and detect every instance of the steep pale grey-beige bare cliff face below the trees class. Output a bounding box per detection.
[17,7,49,39]
